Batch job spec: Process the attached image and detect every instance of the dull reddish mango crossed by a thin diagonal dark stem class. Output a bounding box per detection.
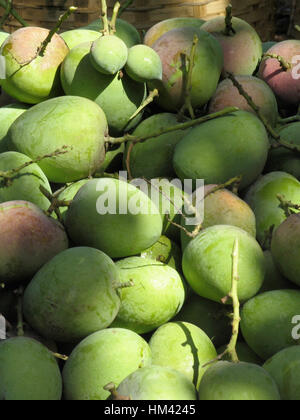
[209,76,279,127]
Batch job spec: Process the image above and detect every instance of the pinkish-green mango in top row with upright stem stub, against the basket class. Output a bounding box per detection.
[201,16,262,76]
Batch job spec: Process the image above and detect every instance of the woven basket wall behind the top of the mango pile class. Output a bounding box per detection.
[0,0,275,40]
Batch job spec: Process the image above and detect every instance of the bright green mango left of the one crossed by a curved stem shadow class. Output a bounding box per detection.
[63,328,151,401]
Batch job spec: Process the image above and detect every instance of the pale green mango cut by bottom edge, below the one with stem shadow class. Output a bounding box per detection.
[117,366,197,401]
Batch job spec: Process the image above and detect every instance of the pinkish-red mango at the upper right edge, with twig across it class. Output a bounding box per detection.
[258,39,300,106]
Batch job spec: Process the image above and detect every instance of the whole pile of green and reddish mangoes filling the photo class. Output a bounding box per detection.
[0,1,300,401]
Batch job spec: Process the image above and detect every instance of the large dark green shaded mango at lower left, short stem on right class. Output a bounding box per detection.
[23,247,120,343]
